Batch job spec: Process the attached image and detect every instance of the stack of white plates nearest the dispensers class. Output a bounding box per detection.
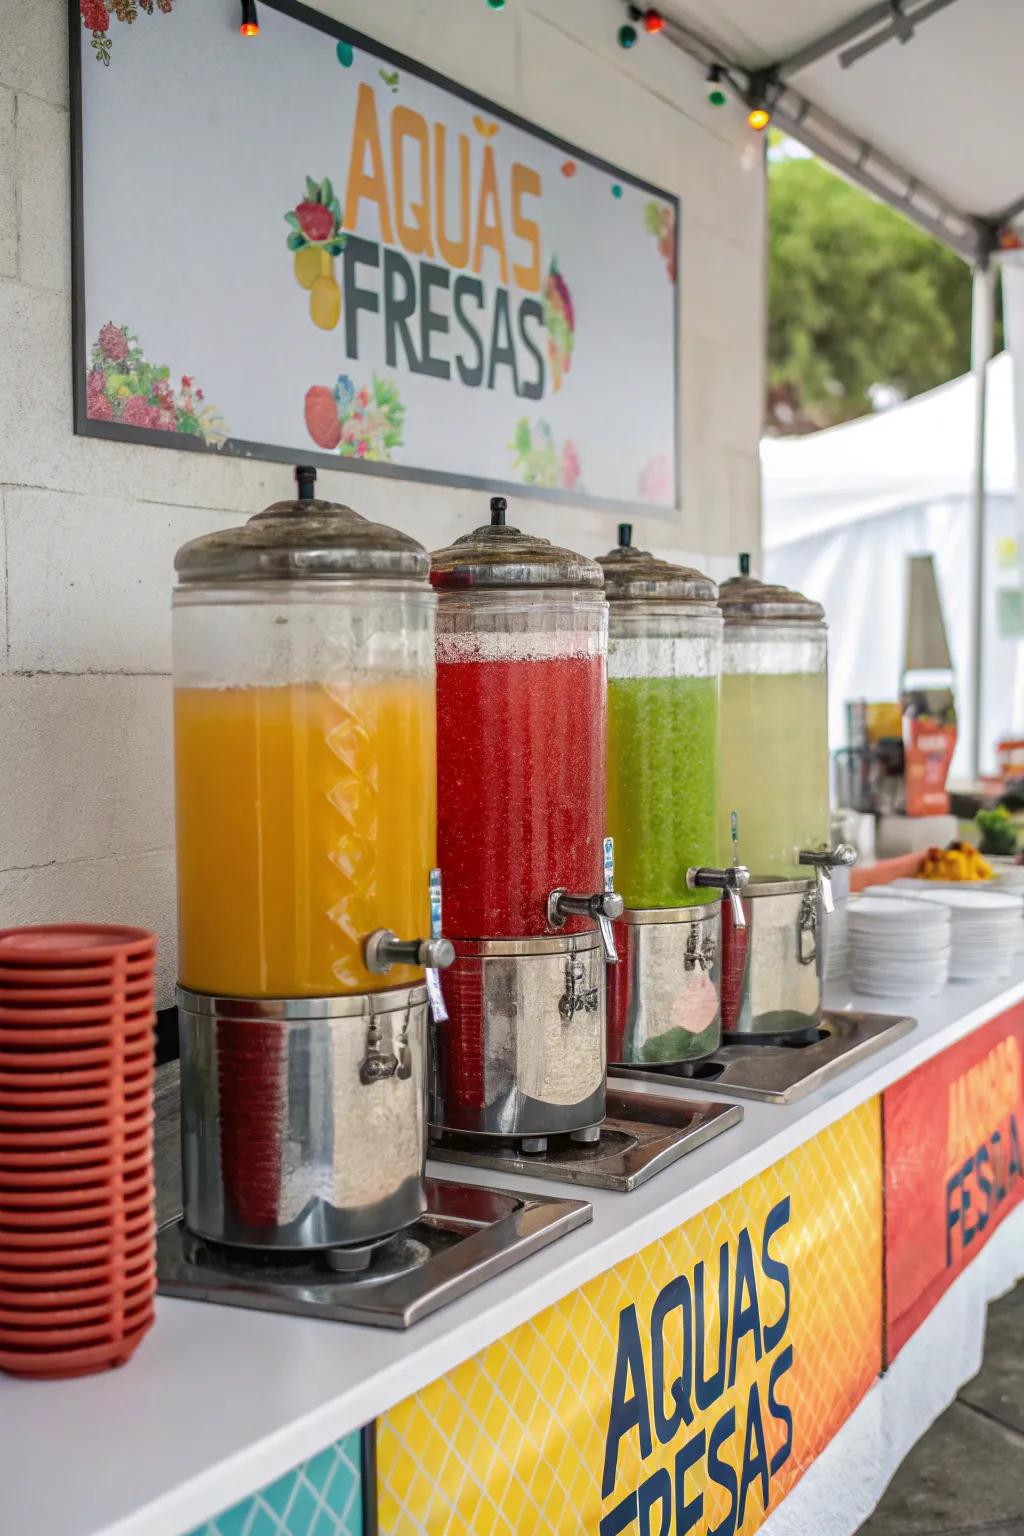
[846,892,952,997]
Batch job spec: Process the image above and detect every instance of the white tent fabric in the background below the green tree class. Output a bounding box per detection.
[761,353,1021,776]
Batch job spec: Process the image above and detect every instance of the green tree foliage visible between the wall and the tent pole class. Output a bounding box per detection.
[768,158,970,430]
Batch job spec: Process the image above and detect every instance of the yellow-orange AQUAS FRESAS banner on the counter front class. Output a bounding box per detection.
[378,1098,881,1536]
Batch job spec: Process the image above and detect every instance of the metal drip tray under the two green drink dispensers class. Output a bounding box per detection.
[614,1009,917,1104]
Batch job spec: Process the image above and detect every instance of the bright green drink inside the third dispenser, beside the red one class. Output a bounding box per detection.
[608,676,718,908]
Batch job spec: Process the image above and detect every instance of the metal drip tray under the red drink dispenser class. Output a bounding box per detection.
[428,1074,743,1192]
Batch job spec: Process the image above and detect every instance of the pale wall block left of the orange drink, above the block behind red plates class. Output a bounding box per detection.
[0,676,173,878]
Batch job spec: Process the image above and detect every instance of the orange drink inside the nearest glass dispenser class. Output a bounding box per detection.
[175,676,436,997]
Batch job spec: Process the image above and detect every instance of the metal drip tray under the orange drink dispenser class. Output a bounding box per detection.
[157,1178,593,1329]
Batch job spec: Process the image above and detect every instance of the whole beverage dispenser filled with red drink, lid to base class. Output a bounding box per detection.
[430,496,622,1152]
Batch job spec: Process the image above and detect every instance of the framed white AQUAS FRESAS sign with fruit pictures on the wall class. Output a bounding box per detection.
[71,0,679,510]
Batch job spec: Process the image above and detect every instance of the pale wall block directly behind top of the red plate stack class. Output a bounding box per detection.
[0,849,178,1008]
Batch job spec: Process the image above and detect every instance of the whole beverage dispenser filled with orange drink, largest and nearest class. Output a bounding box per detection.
[173,472,451,1249]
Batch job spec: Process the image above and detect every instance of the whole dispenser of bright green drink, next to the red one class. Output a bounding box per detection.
[600,524,748,1066]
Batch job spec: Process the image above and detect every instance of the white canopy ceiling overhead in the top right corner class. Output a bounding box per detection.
[662,0,1024,253]
